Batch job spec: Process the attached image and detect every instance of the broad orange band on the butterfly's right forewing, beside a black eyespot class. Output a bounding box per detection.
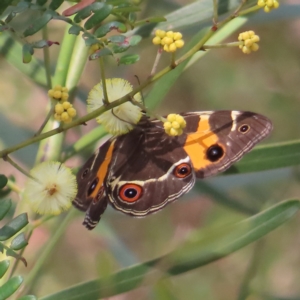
[184,116,218,171]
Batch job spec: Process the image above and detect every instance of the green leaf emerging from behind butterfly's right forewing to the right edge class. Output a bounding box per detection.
[225,140,300,174]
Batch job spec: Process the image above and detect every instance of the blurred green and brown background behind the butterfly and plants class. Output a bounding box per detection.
[0,0,300,300]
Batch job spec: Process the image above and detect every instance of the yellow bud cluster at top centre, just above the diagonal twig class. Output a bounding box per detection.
[152,29,184,52]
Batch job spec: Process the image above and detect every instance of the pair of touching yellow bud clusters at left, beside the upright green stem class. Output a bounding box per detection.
[48,85,76,123]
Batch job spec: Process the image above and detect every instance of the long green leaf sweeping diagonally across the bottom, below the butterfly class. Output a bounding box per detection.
[40,200,300,300]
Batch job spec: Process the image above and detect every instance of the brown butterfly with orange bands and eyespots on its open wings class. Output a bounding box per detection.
[73,111,272,230]
